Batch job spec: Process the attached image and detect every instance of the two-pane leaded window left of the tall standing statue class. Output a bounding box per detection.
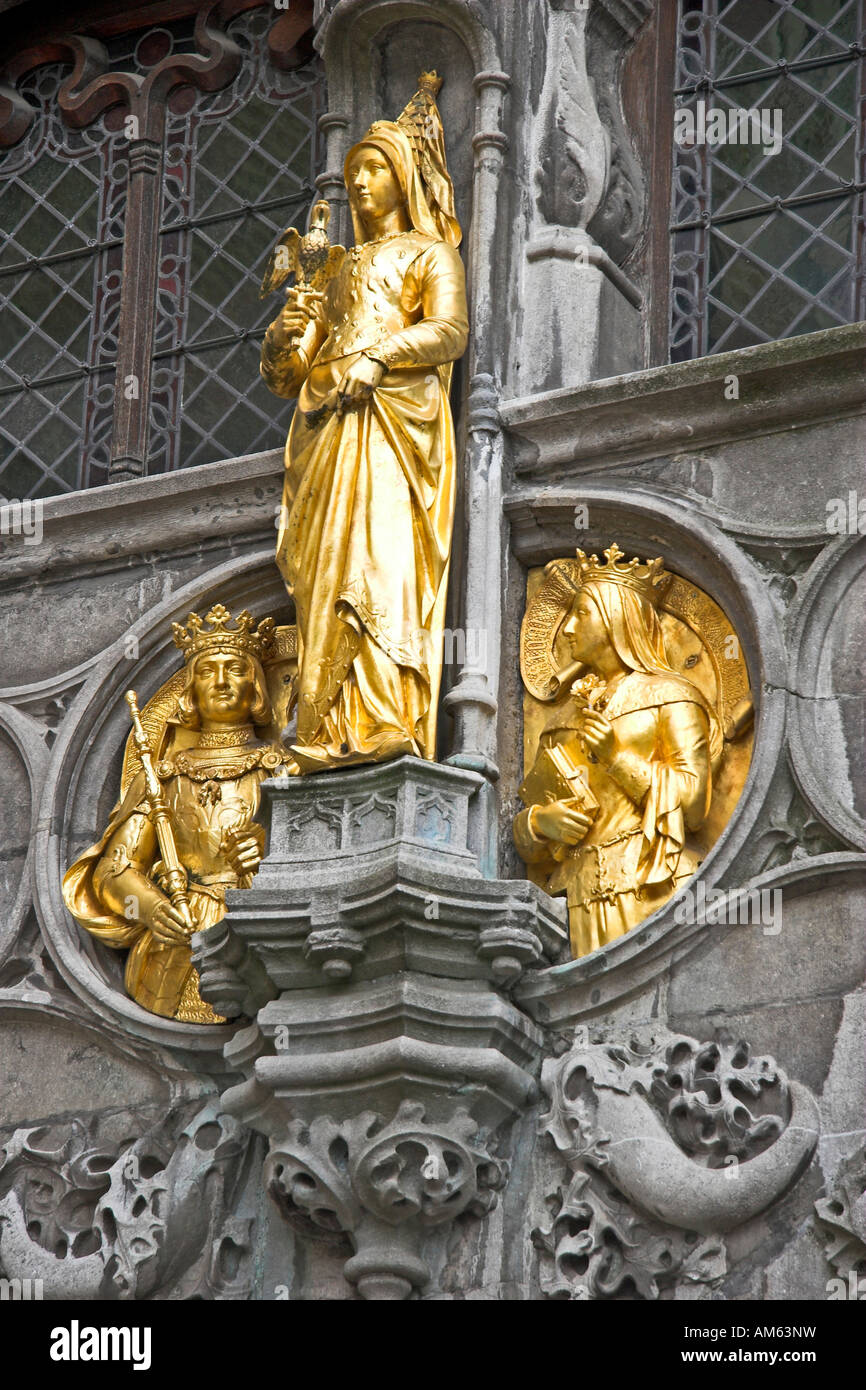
[0,4,325,499]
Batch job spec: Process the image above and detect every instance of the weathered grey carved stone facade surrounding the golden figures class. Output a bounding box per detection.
[0,0,866,1301]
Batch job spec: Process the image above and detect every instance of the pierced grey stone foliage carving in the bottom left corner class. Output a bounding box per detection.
[0,1101,252,1300]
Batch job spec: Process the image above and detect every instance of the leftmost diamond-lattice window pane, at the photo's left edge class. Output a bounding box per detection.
[0,64,128,498]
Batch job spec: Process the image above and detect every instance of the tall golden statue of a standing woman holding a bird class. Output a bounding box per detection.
[261,74,468,771]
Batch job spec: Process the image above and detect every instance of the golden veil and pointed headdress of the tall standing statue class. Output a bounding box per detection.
[343,72,463,246]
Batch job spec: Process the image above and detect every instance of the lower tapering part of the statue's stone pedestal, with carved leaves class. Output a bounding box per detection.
[215,973,542,1300]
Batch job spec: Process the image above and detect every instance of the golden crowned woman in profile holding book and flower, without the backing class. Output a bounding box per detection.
[514,545,724,956]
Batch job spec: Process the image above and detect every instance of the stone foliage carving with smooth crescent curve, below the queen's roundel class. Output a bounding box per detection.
[532,1029,817,1300]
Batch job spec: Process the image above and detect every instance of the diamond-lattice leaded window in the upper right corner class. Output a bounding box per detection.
[670,0,866,361]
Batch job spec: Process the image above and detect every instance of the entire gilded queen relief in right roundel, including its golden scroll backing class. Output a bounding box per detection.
[514,543,752,958]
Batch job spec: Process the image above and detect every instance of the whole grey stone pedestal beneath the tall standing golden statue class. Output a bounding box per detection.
[195,758,566,1300]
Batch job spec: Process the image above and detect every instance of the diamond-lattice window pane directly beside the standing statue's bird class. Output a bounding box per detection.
[147,8,325,473]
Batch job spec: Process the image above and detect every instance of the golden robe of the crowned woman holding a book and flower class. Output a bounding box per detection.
[514,671,712,956]
